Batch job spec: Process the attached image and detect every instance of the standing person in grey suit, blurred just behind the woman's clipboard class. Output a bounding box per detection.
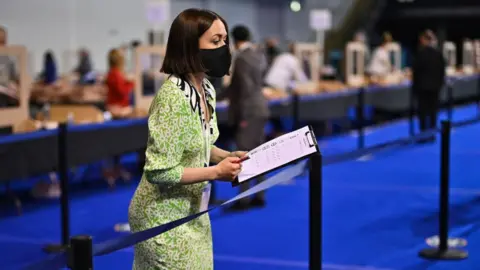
[226,25,269,210]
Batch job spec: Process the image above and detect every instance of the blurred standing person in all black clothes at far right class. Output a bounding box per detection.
[412,31,445,142]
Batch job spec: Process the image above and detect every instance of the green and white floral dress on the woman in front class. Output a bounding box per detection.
[128,76,218,270]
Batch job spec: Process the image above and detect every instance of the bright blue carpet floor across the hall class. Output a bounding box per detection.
[0,104,480,270]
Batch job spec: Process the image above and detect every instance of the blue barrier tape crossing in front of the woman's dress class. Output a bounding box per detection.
[24,161,308,270]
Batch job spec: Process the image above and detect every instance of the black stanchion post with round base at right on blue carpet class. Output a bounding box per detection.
[419,121,468,260]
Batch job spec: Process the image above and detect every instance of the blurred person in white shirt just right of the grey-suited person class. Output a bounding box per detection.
[265,44,308,91]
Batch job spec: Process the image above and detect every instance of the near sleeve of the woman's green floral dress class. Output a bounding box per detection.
[144,81,188,186]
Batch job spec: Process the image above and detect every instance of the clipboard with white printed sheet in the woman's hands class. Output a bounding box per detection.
[232,126,320,187]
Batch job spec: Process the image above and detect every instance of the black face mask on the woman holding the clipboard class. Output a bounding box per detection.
[200,45,232,78]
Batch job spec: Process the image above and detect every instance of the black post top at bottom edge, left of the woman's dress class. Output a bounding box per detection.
[68,235,93,270]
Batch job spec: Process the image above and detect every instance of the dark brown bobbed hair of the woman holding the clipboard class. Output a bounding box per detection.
[160,8,230,76]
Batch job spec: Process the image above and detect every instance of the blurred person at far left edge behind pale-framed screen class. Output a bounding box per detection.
[0,26,19,108]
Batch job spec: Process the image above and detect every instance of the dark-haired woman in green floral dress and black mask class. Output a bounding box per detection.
[129,9,245,270]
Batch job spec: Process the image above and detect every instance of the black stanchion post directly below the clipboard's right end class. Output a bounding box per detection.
[309,154,322,270]
